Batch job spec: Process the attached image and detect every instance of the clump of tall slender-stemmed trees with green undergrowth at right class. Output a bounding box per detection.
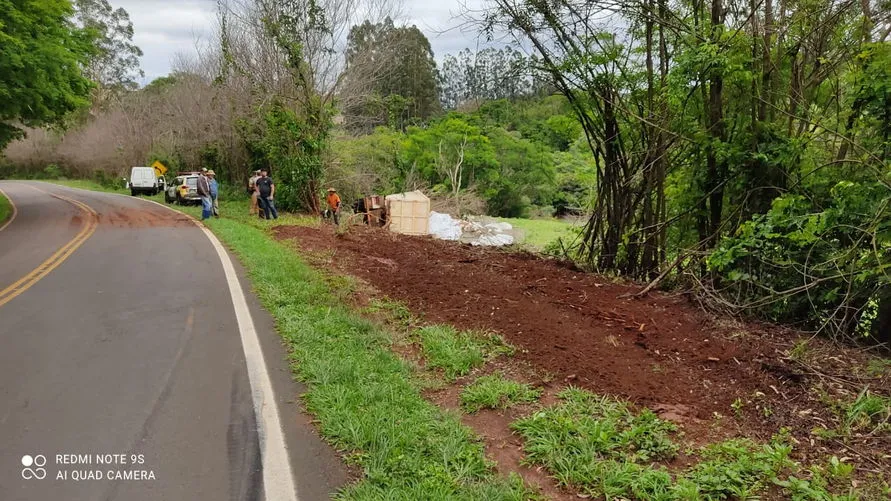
[478,0,891,340]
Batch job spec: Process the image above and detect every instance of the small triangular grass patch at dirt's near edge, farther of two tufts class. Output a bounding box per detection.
[417,325,513,381]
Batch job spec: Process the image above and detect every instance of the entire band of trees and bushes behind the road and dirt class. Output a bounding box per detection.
[0,0,891,344]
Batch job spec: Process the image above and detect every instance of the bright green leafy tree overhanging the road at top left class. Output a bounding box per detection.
[0,0,92,150]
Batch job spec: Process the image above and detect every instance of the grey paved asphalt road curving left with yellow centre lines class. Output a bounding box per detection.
[0,181,348,501]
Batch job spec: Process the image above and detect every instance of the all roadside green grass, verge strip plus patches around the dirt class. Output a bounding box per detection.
[36,182,891,501]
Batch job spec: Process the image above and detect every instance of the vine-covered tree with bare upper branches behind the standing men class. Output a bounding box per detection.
[208,0,391,213]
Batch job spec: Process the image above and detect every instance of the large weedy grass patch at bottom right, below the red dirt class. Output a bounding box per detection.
[512,388,866,501]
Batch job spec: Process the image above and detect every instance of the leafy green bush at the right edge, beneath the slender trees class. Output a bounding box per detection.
[708,181,891,336]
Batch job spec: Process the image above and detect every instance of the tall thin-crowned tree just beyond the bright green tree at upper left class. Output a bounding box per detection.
[75,0,144,111]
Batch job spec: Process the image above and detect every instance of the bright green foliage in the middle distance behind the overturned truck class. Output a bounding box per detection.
[329,96,580,217]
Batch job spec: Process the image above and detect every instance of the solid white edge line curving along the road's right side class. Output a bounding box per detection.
[40,185,299,501]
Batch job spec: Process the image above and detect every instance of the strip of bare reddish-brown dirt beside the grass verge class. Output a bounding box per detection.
[274,226,891,464]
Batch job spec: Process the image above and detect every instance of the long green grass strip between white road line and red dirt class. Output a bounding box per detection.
[188,217,532,500]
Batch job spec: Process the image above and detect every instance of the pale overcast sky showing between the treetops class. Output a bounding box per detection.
[115,0,498,83]
